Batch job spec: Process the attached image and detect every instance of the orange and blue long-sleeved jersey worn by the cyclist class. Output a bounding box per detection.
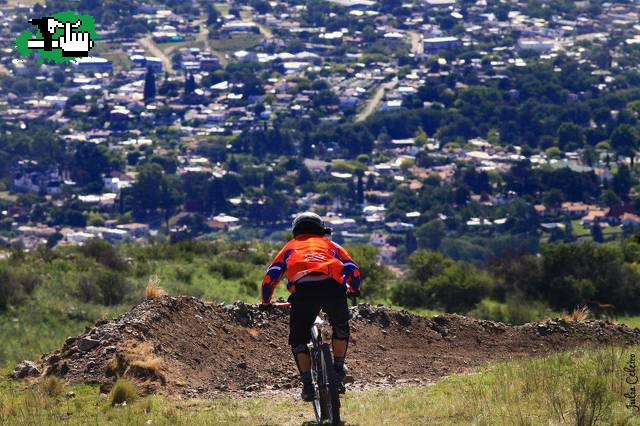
[261,234,360,303]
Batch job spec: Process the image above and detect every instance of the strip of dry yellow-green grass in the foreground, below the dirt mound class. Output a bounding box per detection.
[0,346,640,425]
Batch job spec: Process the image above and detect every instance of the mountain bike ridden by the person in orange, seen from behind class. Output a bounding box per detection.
[274,298,356,425]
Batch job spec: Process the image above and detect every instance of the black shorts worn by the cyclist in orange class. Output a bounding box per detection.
[289,279,349,350]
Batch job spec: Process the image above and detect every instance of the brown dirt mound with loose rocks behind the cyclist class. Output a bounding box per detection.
[32,296,640,398]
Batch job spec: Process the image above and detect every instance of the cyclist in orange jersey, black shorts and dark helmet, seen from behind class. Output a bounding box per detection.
[261,212,360,401]
